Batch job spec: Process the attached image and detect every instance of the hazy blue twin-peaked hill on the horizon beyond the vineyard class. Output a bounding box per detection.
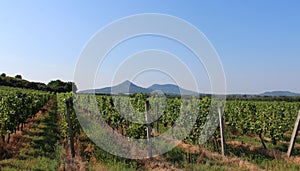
[79,80,198,95]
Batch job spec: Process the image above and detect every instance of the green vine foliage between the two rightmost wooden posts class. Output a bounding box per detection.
[225,101,300,144]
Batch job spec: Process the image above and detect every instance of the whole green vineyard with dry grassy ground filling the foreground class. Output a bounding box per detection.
[0,87,300,170]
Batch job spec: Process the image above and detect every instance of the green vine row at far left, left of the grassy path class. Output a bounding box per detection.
[0,87,51,143]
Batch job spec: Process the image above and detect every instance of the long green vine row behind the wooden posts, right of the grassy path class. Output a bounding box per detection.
[58,93,300,153]
